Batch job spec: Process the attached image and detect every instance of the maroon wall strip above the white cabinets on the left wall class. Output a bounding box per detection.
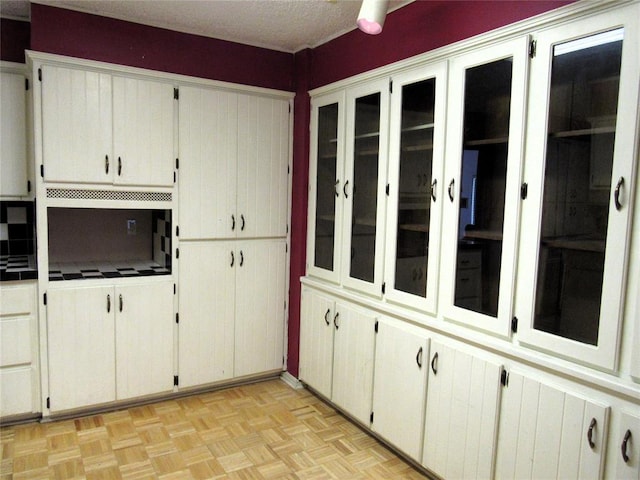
[31,3,293,91]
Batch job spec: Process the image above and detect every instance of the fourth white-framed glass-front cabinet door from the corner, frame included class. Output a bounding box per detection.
[441,38,528,336]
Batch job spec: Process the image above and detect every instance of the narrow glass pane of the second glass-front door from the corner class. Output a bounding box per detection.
[345,93,380,282]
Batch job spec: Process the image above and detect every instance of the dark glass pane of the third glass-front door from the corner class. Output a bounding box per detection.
[395,79,436,297]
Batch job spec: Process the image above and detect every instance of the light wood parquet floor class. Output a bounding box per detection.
[0,380,426,480]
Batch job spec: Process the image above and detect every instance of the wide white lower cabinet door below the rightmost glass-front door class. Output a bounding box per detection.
[496,372,609,479]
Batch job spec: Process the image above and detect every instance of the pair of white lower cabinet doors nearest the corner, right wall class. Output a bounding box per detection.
[300,289,376,425]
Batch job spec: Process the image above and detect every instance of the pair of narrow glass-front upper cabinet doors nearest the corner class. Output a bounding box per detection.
[308,79,389,296]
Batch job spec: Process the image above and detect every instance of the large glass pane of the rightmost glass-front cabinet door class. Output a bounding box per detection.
[534,29,623,345]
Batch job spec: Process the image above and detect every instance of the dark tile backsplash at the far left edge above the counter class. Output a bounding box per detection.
[0,201,36,256]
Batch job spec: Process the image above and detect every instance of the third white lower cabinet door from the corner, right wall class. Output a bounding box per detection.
[371,320,429,461]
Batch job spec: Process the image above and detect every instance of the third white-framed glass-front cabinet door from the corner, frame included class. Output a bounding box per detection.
[385,63,446,314]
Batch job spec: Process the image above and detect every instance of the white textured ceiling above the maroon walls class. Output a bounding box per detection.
[0,0,413,53]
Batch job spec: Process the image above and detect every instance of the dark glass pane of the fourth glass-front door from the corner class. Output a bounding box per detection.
[456,58,513,317]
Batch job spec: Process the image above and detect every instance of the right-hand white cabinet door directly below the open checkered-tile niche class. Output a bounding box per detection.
[115,282,174,400]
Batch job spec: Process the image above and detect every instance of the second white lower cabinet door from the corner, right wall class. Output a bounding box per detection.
[331,302,376,425]
